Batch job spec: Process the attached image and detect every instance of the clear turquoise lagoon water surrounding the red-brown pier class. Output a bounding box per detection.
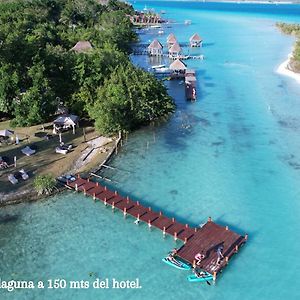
[0,1,300,300]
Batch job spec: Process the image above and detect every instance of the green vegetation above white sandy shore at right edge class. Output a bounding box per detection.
[276,23,300,73]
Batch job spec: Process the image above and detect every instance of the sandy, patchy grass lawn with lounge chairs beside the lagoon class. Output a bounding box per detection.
[0,121,105,193]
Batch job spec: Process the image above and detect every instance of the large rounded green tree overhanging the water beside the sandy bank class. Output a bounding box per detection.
[88,64,174,134]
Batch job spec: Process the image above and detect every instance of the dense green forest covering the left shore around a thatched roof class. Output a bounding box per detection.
[0,0,174,133]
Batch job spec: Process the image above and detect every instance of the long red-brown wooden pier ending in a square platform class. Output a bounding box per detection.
[65,176,247,279]
